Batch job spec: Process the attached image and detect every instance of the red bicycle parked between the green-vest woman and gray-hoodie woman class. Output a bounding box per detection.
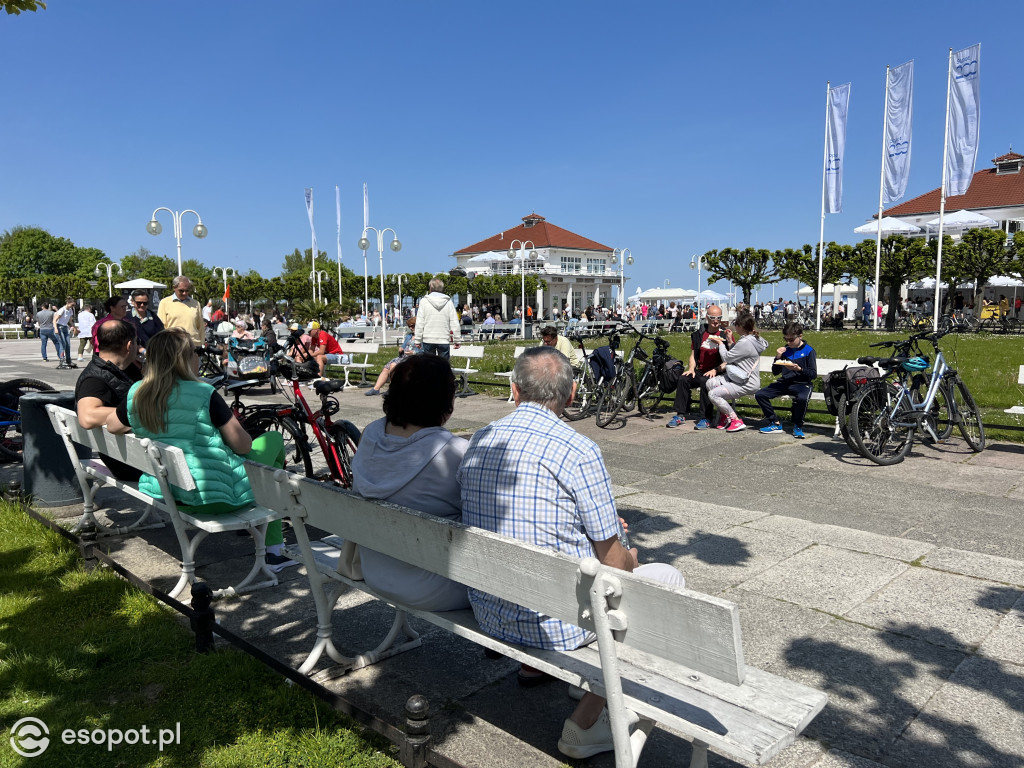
[225,352,361,488]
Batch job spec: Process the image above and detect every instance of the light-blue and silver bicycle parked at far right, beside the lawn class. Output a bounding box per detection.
[850,333,985,465]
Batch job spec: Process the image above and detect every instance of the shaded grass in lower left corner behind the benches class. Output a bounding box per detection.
[0,502,398,768]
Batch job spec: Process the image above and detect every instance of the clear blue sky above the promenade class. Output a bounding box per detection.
[0,0,1024,303]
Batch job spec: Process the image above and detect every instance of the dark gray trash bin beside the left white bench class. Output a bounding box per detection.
[18,392,89,507]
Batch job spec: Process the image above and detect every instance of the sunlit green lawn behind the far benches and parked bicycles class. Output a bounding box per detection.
[348,331,1024,442]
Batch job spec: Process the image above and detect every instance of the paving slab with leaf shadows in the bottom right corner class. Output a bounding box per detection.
[886,657,1024,768]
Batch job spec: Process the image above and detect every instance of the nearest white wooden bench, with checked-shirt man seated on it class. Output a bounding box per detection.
[246,463,827,768]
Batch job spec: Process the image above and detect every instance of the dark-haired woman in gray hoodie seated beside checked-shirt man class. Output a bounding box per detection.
[352,354,469,610]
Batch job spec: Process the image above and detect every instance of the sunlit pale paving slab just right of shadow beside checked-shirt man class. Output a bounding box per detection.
[743,546,907,615]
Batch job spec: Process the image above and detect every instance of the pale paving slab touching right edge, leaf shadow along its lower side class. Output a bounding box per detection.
[846,568,1024,650]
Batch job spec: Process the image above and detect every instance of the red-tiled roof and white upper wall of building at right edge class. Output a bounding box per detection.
[883,152,1024,236]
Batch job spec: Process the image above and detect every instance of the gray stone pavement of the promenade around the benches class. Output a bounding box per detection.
[0,342,1024,768]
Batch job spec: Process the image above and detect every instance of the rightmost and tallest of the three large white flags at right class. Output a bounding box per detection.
[945,43,981,197]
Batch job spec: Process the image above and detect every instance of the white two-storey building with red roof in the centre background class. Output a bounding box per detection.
[452,213,629,319]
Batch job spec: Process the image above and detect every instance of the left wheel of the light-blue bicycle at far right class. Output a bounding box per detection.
[850,385,914,466]
